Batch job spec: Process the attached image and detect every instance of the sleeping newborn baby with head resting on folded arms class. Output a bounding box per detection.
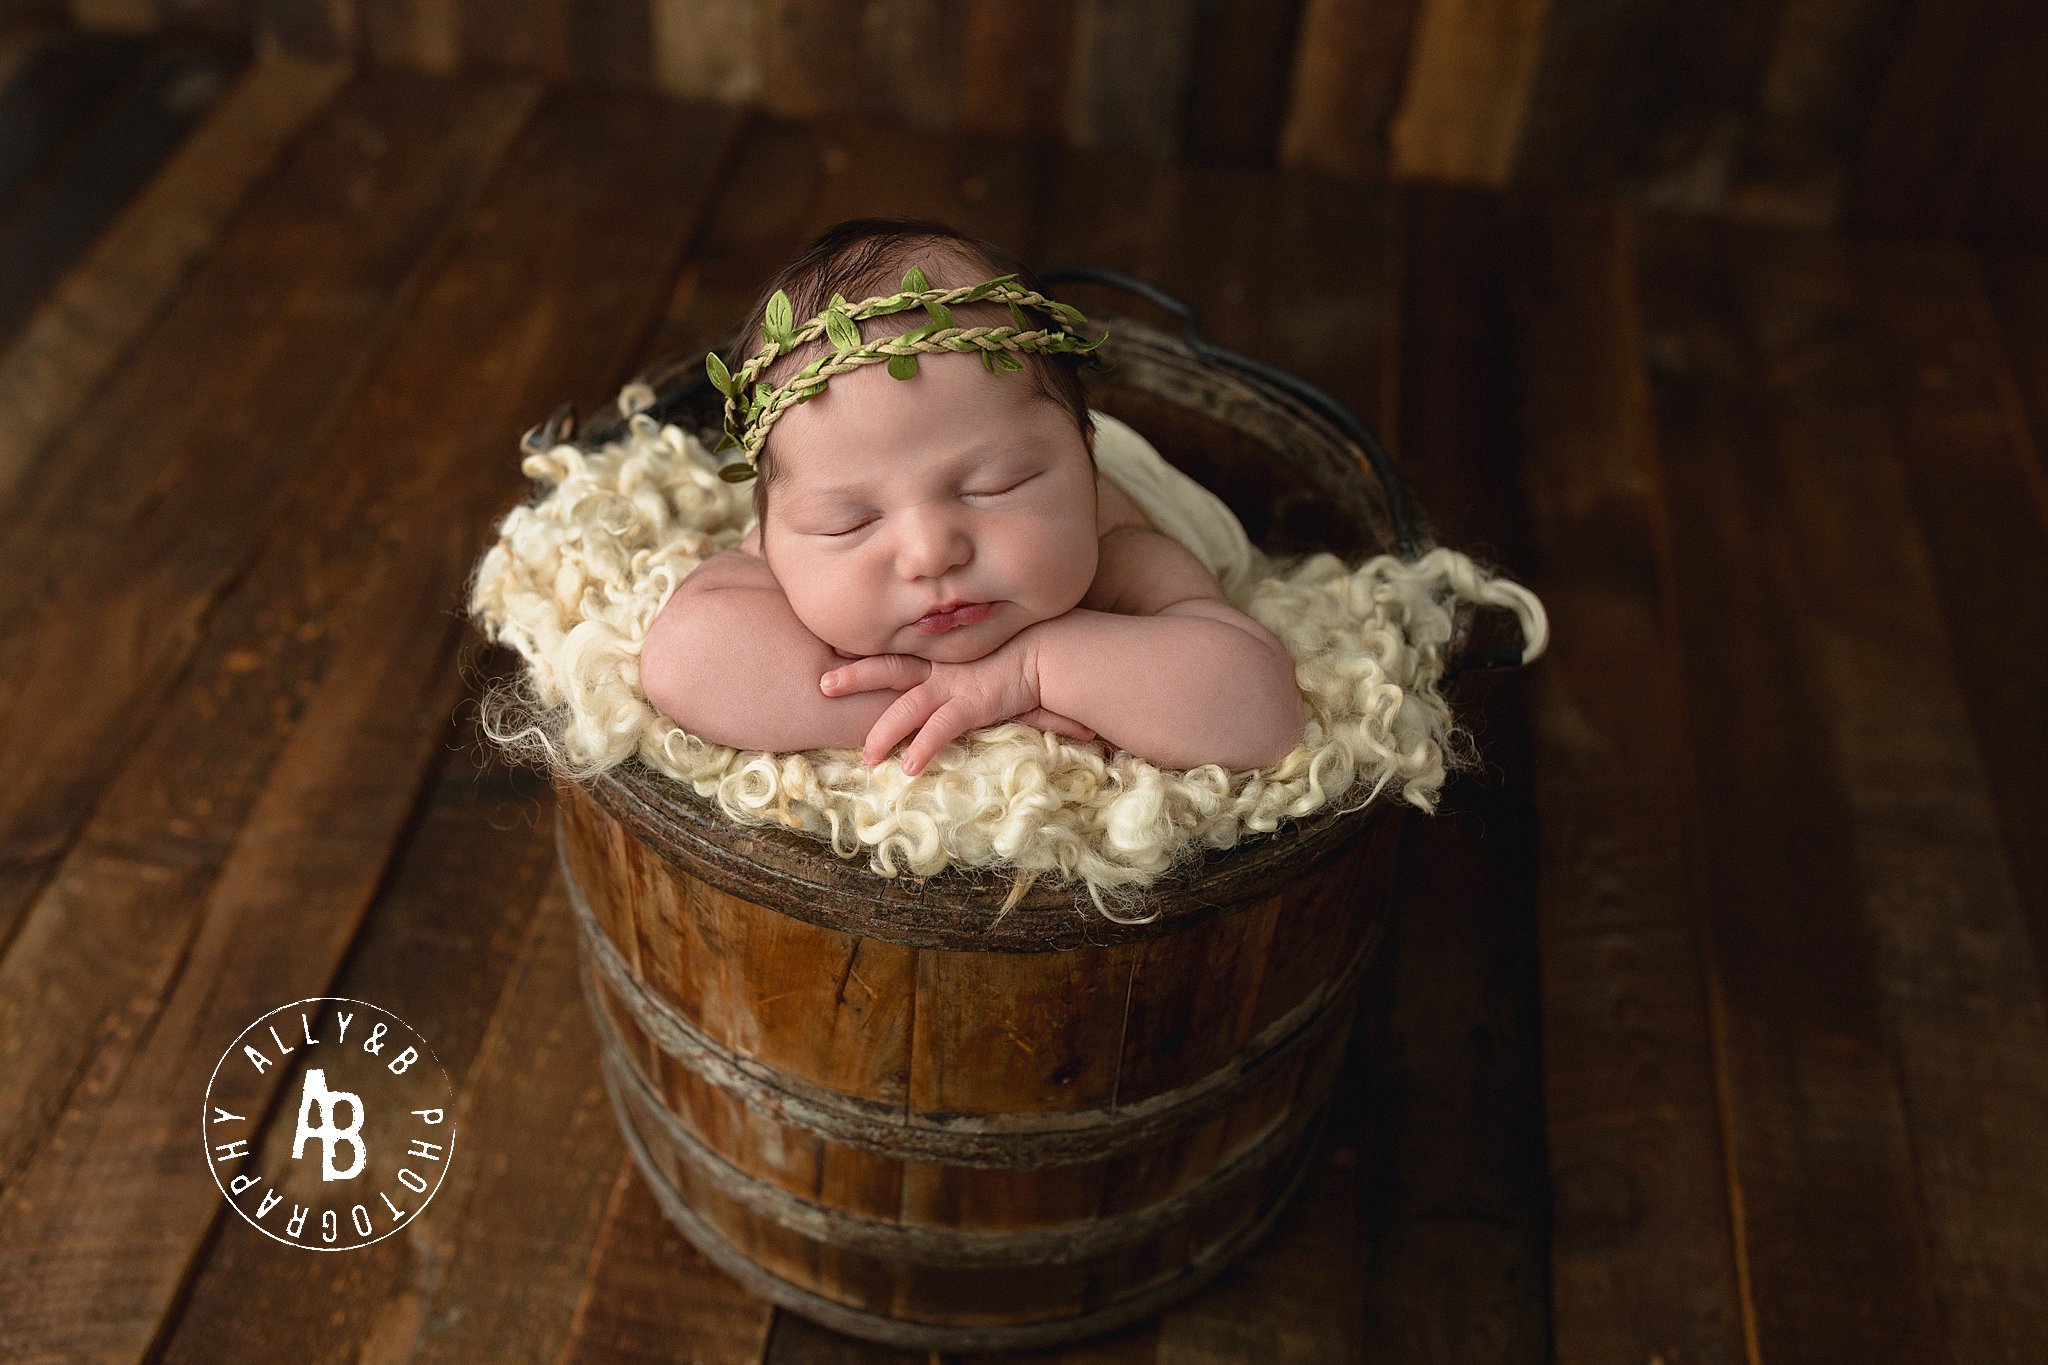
[641,219,1303,774]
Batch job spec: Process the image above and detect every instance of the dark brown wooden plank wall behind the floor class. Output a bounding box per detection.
[12,0,2048,239]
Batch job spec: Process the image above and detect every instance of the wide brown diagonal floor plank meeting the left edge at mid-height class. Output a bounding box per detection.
[0,78,530,957]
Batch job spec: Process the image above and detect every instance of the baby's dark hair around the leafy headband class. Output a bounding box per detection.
[725,219,1094,532]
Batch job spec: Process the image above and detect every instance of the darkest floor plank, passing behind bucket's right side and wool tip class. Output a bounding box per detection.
[1354,186,1550,1361]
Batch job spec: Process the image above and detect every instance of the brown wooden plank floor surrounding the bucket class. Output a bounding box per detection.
[0,29,2048,1365]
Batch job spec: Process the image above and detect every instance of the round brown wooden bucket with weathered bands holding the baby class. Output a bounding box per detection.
[557,319,1433,1351]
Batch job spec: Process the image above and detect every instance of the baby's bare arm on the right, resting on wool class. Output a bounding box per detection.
[1030,526,1303,772]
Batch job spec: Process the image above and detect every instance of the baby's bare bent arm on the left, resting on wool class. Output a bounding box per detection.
[641,551,901,753]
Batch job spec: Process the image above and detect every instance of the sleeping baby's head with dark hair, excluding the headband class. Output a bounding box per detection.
[731,219,1096,663]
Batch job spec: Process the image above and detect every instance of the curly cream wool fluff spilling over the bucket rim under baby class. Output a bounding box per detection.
[469,395,1546,919]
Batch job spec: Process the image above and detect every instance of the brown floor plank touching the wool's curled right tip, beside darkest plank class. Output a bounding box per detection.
[1513,203,1745,1363]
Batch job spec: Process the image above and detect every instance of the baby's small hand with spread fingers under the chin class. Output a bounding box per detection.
[817,634,1096,774]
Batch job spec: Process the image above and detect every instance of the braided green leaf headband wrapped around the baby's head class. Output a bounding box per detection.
[705,266,1110,483]
